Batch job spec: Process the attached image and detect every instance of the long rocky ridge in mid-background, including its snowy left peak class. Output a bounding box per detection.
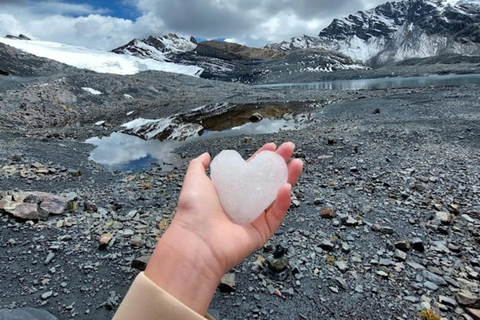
[113,34,363,84]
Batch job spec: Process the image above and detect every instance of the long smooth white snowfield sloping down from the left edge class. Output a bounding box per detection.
[0,38,203,77]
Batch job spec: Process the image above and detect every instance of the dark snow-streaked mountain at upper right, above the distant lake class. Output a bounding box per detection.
[267,0,480,65]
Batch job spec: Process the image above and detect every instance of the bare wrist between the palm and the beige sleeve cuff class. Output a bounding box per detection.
[145,223,223,315]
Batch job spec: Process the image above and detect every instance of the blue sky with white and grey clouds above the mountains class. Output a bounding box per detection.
[0,0,402,49]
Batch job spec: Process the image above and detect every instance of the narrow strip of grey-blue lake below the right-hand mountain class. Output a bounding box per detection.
[256,74,480,90]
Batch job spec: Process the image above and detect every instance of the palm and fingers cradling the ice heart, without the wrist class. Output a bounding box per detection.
[171,143,302,274]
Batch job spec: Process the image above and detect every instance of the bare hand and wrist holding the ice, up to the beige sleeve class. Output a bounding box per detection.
[145,142,303,315]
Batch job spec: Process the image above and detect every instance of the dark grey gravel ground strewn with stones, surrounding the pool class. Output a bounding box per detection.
[0,52,480,320]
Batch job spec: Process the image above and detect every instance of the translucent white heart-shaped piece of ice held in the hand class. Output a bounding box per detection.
[210,150,288,224]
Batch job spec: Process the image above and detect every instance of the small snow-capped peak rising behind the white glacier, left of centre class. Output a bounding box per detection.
[112,33,197,61]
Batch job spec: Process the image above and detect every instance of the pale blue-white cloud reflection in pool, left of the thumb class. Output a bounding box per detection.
[85,132,179,171]
